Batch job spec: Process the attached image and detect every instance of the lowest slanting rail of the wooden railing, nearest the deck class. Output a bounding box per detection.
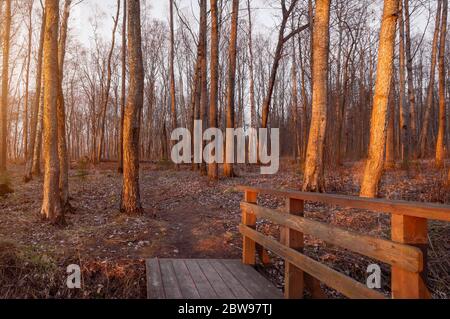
[239,225,384,299]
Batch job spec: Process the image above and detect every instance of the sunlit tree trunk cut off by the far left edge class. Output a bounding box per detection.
[0,0,11,175]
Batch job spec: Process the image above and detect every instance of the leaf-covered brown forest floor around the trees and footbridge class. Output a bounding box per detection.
[0,161,450,298]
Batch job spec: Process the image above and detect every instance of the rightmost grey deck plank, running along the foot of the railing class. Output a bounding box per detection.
[222,260,283,299]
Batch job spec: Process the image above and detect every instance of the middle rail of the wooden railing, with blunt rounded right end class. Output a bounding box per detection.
[241,203,423,272]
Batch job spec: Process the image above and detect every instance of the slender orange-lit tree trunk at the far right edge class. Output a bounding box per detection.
[436,0,448,168]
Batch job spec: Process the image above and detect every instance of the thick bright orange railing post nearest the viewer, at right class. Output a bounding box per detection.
[391,214,430,299]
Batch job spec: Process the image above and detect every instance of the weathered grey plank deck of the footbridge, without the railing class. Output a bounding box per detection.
[146,258,283,299]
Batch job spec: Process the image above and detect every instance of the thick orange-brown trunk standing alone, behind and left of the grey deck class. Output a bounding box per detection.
[121,0,144,214]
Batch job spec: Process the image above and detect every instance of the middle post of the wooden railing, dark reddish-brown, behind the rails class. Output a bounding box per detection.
[282,198,305,299]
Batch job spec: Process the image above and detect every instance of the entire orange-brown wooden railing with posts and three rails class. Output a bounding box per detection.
[238,186,450,299]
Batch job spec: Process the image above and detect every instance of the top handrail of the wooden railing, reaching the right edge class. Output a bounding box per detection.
[237,186,450,221]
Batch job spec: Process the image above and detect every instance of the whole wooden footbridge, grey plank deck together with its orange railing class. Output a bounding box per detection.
[147,186,450,299]
